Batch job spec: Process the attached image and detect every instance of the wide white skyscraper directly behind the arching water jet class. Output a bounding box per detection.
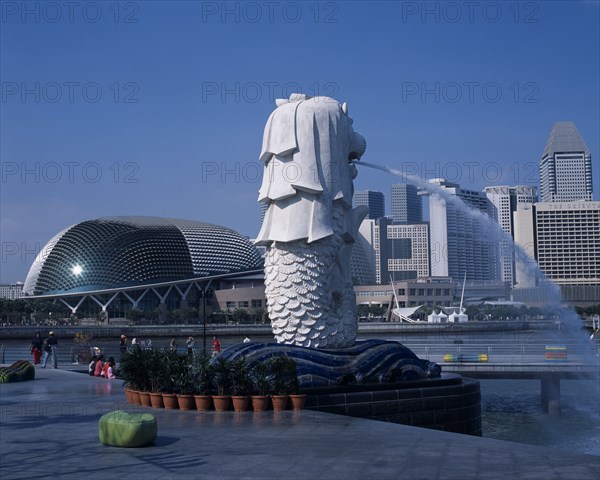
[429,178,499,282]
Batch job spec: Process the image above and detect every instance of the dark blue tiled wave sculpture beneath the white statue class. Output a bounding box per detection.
[220,340,441,388]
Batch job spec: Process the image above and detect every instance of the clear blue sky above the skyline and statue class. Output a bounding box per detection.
[0,1,600,283]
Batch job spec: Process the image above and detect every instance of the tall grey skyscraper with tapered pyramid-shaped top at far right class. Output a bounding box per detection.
[540,122,592,202]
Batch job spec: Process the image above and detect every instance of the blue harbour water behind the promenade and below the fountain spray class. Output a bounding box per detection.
[1,332,600,456]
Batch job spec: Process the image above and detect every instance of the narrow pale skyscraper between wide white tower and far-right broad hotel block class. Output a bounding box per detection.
[484,185,537,287]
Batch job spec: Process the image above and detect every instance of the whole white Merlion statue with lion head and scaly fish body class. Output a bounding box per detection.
[256,94,367,347]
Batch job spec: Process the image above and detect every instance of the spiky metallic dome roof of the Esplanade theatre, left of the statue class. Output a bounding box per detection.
[23,217,262,295]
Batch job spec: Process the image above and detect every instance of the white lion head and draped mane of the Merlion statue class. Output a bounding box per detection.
[257,94,366,245]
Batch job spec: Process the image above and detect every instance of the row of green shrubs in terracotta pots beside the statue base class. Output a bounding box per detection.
[119,347,306,411]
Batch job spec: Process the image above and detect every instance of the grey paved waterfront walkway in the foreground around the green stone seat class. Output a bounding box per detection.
[0,367,600,480]
